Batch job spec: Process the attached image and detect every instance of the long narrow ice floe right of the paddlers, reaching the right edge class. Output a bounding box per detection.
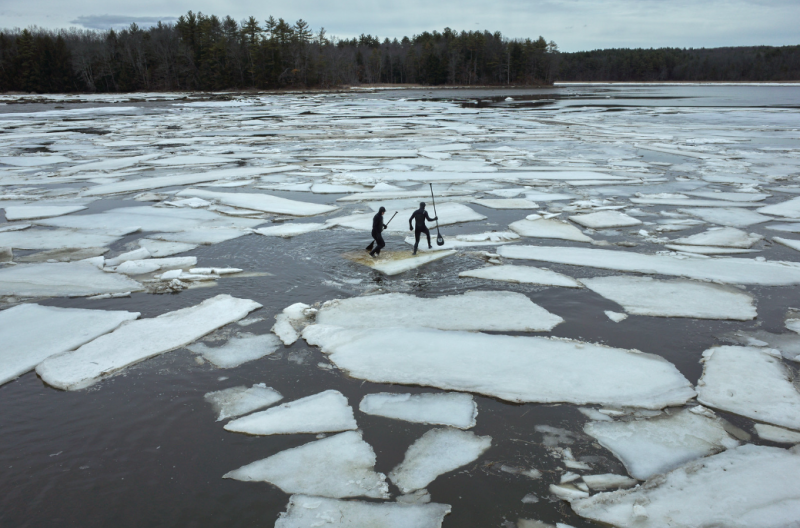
[497,245,800,286]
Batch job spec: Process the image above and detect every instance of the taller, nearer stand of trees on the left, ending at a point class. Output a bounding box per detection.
[0,11,557,93]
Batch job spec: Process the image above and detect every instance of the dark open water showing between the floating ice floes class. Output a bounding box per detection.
[0,86,800,528]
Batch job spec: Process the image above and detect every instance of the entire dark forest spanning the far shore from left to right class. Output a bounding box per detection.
[0,11,800,93]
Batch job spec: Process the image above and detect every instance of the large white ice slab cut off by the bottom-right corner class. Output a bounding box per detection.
[571,445,800,528]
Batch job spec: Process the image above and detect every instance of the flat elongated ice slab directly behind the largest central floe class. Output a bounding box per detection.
[316,291,564,332]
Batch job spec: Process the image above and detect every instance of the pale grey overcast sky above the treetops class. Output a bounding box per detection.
[0,0,800,51]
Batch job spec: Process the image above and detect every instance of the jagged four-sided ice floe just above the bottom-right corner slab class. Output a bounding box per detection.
[583,409,739,480]
